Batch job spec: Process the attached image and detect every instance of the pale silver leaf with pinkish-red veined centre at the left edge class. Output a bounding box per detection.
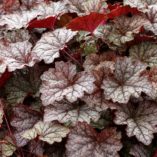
[0,41,37,71]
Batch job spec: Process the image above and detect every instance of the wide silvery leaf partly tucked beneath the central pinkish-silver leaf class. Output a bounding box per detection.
[44,101,100,125]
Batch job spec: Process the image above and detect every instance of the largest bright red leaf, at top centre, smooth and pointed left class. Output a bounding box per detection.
[67,12,107,33]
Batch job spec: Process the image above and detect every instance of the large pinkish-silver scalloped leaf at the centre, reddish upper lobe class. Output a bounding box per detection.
[40,61,95,106]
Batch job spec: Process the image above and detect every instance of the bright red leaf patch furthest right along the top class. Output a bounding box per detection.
[108,4,140,19]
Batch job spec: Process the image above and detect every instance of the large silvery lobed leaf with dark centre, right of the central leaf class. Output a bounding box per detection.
[102,58,155,103]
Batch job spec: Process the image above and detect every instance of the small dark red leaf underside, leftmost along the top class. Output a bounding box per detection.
[28,16,56,29]
